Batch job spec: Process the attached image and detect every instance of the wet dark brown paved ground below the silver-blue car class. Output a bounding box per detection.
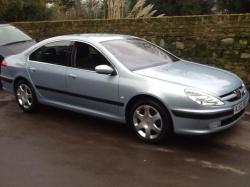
[0,91,250,187]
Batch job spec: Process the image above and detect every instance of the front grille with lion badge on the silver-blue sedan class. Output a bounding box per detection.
[220,86,246,102]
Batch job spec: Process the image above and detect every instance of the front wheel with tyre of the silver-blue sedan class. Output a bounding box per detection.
[128,99,173,143]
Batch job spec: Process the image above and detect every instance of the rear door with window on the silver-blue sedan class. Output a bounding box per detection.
[28,41,72,102]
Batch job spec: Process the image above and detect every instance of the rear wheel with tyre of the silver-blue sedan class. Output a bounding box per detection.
[15,80,38,112]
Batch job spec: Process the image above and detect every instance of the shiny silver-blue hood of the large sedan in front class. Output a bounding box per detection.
[134,61,242,96]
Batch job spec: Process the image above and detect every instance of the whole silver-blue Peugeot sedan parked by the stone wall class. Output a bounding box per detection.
[1,34,249,143]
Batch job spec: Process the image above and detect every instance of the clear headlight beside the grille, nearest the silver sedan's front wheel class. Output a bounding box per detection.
[185,89,224,106]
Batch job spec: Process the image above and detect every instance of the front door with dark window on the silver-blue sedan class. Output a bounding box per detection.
[67,42,122,115]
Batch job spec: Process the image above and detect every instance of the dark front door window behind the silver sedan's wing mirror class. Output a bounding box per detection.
[74,42,109,71]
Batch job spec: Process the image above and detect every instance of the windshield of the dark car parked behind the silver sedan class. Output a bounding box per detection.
[0,25,32,46]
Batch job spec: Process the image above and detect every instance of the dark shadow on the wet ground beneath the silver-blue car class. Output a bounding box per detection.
[0,91,250,157]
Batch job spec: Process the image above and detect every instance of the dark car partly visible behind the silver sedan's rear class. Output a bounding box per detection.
[0,24,36,88]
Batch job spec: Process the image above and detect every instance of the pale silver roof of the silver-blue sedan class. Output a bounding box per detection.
[46,33,136,43]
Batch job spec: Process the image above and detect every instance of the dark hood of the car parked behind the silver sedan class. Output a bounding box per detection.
[0,40,36,58]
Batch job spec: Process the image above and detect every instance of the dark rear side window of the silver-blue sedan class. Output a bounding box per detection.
[29,41,72,66]
